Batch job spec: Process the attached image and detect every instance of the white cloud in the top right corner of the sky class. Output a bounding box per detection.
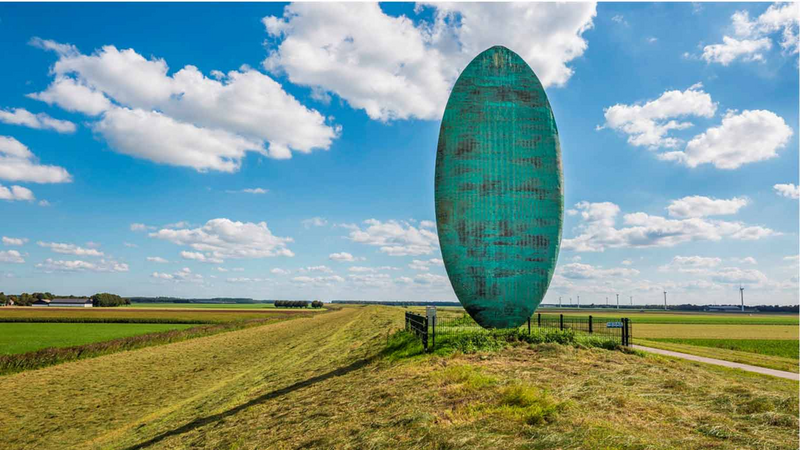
[702,3,800,66]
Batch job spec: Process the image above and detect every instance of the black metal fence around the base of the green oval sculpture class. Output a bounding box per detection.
[406,312,632,350]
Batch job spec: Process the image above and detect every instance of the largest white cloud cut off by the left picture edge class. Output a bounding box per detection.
[0,136,72,183]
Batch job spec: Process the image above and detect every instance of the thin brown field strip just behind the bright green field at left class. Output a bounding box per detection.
[0,307,314,323]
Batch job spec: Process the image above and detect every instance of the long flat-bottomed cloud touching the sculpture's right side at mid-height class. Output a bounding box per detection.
[561,202,779,252]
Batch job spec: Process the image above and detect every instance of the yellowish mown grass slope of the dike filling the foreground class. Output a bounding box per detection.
[0,306,798,449]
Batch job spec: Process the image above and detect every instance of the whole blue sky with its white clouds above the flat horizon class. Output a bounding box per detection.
[0,3,798,304]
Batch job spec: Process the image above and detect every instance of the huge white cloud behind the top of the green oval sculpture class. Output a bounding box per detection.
[263,3,596,121]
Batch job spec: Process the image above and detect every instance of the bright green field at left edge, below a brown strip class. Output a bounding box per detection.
[0,323,197,355]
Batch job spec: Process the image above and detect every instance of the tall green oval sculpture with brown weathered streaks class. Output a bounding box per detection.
[435,46,564,328]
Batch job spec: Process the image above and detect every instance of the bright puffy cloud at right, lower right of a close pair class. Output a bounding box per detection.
[659,110,792,169]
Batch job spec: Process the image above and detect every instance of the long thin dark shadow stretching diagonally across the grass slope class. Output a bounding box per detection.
[127,355,380,450]
